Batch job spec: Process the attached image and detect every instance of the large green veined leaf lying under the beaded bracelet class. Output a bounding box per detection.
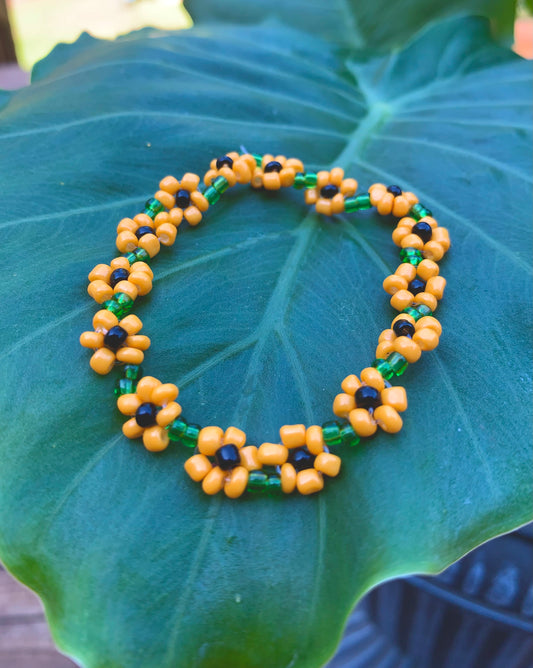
[0,11,531,668]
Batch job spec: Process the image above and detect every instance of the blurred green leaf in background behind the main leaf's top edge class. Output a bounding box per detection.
[186,0,516,48]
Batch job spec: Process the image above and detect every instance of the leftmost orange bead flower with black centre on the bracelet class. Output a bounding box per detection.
[80,316,150,375]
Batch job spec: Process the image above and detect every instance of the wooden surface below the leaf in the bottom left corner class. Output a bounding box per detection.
[0,565,76,668]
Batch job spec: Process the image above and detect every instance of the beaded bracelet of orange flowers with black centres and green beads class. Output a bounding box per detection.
[80,151,450,498]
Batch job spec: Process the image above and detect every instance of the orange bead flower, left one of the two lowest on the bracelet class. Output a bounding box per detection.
[184,428,248,499]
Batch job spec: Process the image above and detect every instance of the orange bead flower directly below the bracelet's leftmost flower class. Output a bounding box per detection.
[117,376,181,452]
